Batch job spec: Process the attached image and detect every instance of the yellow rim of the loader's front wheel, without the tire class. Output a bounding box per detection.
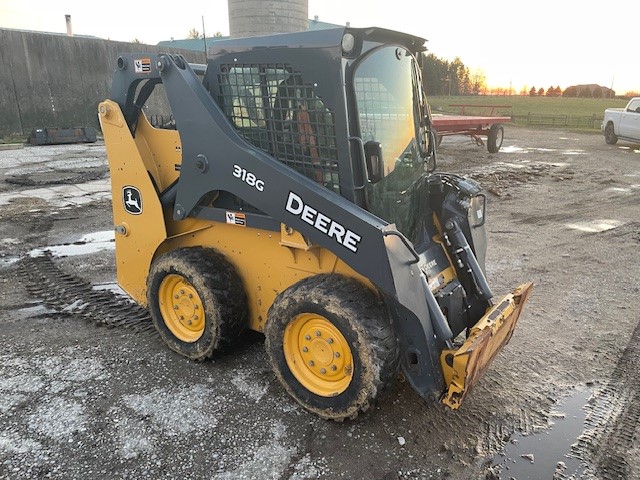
[283,313,353,397]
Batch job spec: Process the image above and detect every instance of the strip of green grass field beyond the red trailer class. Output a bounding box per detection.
[428,95,627,118]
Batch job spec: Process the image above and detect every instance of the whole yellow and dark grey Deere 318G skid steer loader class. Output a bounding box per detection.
[98,28,531,420]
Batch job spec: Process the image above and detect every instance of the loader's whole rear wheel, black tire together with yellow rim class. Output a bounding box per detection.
[147,247,248,360]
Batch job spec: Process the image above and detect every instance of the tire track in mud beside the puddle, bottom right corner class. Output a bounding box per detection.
[573,316,640,480]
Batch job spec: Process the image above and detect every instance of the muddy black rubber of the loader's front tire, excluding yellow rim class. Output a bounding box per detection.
[265,275,399,421]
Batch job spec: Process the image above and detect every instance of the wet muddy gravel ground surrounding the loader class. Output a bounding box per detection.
[0,126,640,479]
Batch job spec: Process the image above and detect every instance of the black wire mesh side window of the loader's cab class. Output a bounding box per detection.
[218,64,340,193]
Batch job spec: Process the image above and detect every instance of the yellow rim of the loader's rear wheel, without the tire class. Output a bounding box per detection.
[158,274,205,343]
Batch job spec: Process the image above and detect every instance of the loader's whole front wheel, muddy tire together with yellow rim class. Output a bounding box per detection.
[265,275,399,421]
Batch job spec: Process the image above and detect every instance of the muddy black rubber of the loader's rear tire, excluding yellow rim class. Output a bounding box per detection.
[147,247,249,361]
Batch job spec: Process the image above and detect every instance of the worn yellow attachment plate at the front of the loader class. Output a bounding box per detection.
[440,283,533,410]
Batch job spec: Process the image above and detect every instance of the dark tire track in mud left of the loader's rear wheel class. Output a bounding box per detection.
[18,253,155,332]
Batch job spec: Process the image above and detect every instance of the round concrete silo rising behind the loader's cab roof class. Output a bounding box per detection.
[228,0,309,37]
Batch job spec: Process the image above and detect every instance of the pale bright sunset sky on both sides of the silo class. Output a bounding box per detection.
[0,0,640,94]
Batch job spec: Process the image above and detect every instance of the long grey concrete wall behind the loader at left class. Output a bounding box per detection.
[0,29,204,138]
